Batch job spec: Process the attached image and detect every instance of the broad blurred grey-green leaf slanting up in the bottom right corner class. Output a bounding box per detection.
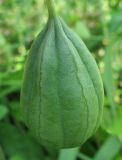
[93,136,122,160]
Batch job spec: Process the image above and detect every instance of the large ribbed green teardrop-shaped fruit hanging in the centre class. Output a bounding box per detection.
[21,17,104,148]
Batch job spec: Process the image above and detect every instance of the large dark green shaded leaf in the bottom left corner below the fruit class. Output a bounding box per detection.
[0,123,44,160]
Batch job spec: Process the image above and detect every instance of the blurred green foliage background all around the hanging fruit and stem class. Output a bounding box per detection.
[0,0,122,160]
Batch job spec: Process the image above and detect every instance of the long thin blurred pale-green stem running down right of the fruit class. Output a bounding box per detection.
[99,0,117,118]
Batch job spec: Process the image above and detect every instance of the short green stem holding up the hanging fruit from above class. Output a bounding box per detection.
[45,0,56,18]
